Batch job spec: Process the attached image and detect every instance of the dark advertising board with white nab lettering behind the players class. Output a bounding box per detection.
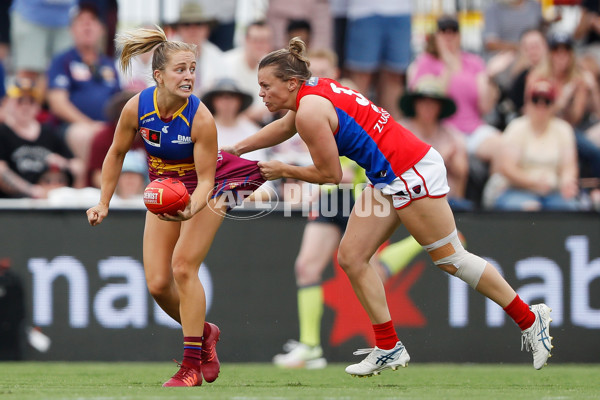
[0,210,600,363]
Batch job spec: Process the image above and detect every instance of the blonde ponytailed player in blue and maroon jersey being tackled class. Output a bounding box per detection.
[87,29,264,386]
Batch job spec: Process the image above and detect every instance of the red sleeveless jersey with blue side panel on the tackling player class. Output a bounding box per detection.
[296,77,431,184]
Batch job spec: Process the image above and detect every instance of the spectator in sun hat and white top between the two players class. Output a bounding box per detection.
[202,78,267,161]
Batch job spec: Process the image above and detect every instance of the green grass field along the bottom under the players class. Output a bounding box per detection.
[0,362,600,400]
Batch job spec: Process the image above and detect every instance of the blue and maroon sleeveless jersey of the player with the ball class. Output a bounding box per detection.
[138,87,200,192]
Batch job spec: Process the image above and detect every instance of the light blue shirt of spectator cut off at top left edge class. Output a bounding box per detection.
[11,0,79,28]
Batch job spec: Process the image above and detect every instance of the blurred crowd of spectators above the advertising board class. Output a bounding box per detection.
[0,0,600,211]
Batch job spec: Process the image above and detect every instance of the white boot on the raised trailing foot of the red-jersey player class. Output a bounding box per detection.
[521,304,554,369]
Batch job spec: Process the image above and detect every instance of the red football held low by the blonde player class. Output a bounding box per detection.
[144,178,190,215]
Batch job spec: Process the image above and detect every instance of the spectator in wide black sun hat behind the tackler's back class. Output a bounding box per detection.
[399,75,473,210]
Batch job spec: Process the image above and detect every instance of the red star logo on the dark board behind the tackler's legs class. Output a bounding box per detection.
[323,260,427,346]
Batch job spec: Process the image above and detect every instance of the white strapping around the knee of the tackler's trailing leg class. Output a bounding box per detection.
[423,229,487,289]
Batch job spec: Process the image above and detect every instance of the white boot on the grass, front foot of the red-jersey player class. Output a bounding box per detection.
[346,342,410,378]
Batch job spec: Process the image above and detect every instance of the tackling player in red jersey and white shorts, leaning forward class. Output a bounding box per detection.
[224,38,552,376]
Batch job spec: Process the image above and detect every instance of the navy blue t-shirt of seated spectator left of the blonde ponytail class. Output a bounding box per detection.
[48,48,121,121]
